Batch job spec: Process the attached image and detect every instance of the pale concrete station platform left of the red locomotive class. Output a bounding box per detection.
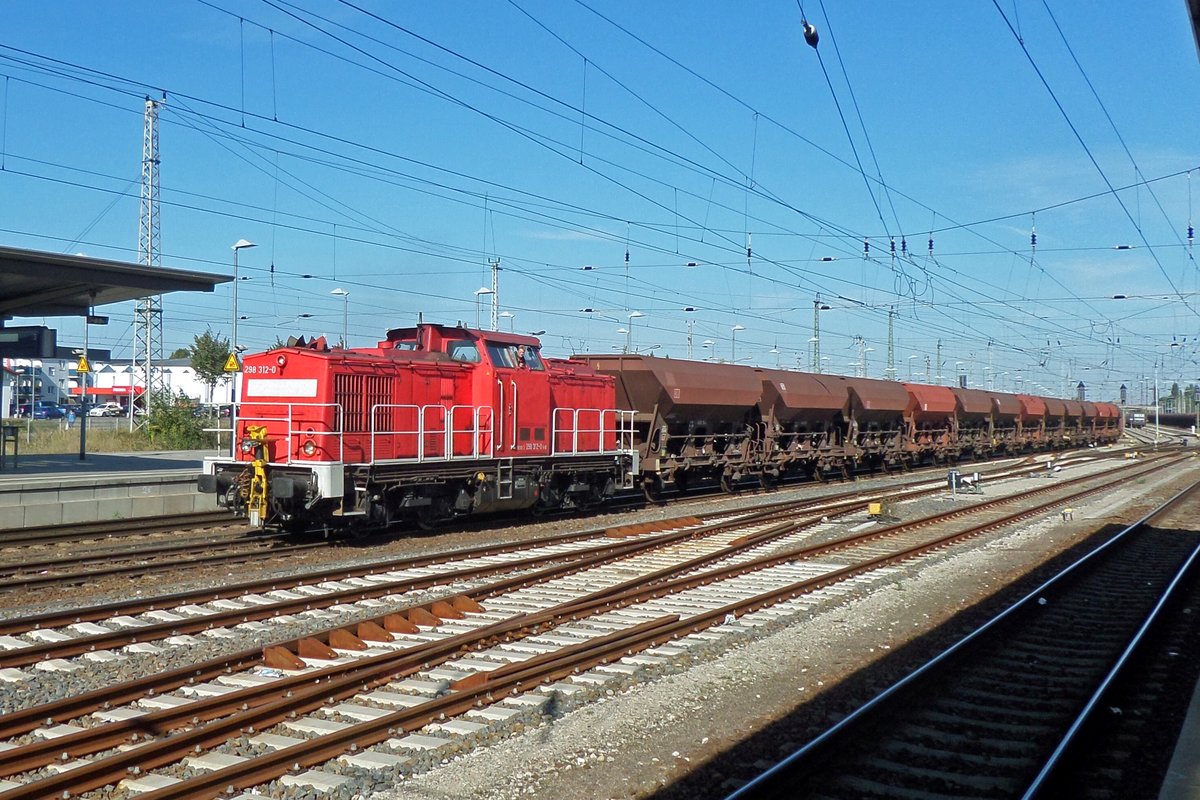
[0,450,216,534]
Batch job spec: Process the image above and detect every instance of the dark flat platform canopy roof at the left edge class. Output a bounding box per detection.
[0,247,226,320]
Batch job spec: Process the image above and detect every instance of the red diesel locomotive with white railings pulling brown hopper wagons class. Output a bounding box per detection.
[199,324,635,530]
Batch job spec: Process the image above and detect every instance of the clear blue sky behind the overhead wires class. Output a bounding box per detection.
[0,0,1200,399]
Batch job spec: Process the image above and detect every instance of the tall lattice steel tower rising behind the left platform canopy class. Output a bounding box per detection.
[130,97,167,425]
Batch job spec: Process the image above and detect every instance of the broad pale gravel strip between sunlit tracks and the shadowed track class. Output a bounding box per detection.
[379,455,1196,800]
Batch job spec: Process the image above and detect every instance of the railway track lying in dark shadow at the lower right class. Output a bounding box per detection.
[731,474,1200,800]
